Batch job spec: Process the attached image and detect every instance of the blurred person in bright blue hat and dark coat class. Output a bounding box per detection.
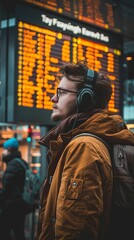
[0,138,28,240]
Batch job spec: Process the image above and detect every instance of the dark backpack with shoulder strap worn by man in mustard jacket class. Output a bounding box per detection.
[73,133,134,210]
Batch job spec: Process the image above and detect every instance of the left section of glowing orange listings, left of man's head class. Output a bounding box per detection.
[18,22,71,110]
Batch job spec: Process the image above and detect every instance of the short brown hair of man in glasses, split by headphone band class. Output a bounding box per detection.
[60,62,112,109]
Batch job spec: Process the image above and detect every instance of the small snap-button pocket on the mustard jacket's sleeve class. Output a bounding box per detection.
[66,178,83,200]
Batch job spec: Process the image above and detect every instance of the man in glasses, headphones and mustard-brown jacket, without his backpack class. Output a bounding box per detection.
[36,62,134,240]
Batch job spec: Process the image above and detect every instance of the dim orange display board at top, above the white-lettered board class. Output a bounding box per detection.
[22,0,122,32]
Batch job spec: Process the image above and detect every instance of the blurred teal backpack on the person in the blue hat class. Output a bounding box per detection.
[16,158,40,205]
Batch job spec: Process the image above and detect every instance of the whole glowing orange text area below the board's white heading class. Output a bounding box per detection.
[18,22,121,112]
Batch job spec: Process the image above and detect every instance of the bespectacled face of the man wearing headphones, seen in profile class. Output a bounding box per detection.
[51,76,77,121]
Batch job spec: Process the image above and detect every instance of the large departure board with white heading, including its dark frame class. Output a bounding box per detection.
[2,3,122,125]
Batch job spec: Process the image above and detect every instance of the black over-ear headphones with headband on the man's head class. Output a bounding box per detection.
[77,69,98,112]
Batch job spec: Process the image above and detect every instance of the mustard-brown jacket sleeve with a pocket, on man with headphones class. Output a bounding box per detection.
[55,137,112,240]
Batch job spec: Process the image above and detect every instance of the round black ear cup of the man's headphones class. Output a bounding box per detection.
[77,86,96,112]
